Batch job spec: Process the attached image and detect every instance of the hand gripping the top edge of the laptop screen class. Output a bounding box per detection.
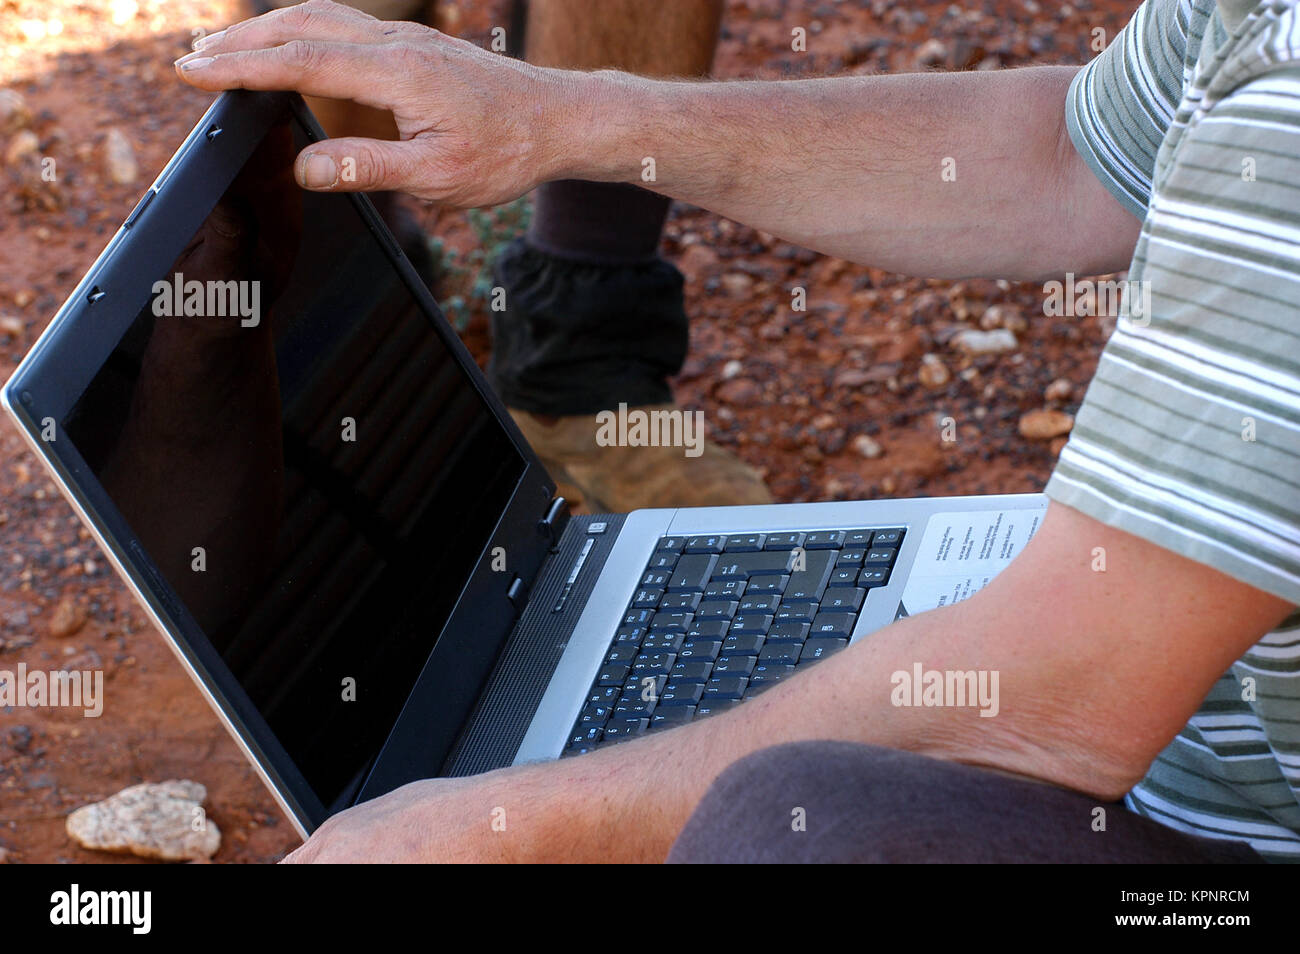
[177,0,563,208]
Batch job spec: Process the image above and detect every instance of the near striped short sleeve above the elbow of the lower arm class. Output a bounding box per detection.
[1047,66,1300,603]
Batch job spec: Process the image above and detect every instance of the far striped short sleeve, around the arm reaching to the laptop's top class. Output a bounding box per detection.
[1065,0,1214,218]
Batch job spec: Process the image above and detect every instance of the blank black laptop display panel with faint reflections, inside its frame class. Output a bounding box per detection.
[64,121,525,806]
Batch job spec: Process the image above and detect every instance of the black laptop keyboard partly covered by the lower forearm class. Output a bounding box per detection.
[564,528,905,755]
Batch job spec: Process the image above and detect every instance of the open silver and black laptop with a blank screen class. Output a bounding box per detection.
[3,91,1047,837]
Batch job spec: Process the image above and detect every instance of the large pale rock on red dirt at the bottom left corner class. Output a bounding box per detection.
[66,779,221,862]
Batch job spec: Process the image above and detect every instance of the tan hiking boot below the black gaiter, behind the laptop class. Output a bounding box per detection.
[510,404,772,513]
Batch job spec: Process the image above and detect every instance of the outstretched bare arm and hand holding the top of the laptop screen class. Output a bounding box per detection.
[178,0,1139,278]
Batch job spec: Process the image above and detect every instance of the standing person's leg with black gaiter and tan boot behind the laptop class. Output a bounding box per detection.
[489,0,771,511]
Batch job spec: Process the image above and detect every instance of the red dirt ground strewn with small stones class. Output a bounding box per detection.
[0,0,1136,862]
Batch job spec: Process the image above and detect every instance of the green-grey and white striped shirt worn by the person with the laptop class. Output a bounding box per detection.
[1047,0,1300,862]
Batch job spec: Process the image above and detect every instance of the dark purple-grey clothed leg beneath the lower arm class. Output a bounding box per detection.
[668,742,1264,864]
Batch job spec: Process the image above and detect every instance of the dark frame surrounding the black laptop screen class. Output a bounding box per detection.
[0,90,555,836]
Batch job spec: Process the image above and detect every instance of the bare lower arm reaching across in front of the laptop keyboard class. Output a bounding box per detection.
[294,503,1288,862]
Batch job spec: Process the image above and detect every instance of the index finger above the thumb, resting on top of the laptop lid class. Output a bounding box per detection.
[177,39,393,109]
